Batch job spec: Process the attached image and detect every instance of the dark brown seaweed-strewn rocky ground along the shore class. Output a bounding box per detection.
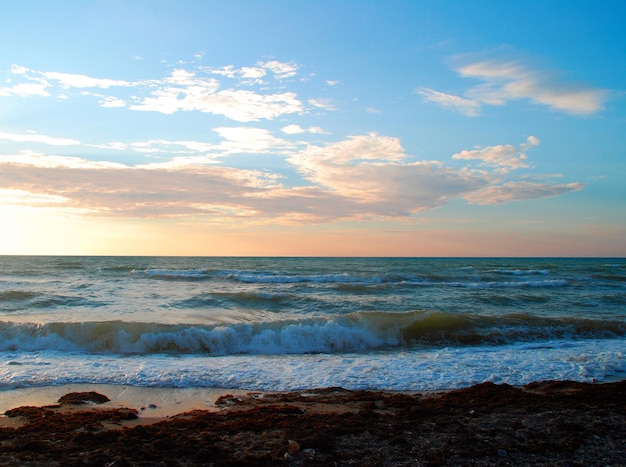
[0,381,626,467]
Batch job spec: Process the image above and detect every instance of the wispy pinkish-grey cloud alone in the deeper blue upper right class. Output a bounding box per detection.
[456,60,607,115]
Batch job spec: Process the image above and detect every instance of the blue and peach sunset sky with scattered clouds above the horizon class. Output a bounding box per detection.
[0,0,626,257]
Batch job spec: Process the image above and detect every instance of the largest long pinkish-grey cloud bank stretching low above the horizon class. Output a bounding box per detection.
[0,134,584,223]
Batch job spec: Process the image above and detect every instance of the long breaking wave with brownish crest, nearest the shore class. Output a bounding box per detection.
[0,311,626,355]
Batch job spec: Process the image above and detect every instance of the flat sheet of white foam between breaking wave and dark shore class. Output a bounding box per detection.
[0,339,626,391]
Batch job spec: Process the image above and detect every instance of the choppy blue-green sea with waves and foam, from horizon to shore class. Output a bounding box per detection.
[0,256,626,391]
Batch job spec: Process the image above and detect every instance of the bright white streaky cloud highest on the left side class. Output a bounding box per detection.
[0,60,305,122]
